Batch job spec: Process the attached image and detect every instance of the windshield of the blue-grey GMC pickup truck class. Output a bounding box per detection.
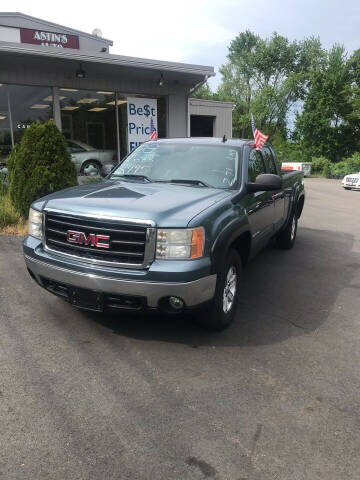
[110,142,239,188]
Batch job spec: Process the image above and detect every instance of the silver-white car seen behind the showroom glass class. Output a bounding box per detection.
[66,140,117,177]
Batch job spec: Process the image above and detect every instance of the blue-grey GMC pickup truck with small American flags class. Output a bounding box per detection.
[23,138,305,330]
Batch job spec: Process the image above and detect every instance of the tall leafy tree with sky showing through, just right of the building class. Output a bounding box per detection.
[217,30,324,137]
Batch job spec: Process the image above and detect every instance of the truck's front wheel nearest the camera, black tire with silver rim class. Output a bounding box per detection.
[196,249,242,331]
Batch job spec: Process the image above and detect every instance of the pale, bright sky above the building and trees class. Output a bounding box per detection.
[8,0,360,89]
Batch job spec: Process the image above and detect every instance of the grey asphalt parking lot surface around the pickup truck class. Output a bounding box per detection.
[0,179,360,480]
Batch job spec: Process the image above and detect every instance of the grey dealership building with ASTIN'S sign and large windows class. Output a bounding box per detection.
[0,13,233,161]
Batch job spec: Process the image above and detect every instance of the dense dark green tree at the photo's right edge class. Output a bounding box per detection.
[295,45,360,162]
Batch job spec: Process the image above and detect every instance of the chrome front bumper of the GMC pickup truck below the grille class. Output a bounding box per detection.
[24,254,216,308]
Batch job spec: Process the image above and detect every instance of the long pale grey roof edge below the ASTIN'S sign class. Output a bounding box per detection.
[0,42,215,77]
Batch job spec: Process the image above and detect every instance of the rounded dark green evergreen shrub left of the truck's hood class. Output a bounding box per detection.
[8,121,77,218]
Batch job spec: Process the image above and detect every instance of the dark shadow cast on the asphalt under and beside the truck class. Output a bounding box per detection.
[85,228,360,347]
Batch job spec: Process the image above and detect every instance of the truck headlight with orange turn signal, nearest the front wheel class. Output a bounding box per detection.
[156,227,205,259]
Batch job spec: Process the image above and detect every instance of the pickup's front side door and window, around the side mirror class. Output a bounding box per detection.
[247,149,274,250]
